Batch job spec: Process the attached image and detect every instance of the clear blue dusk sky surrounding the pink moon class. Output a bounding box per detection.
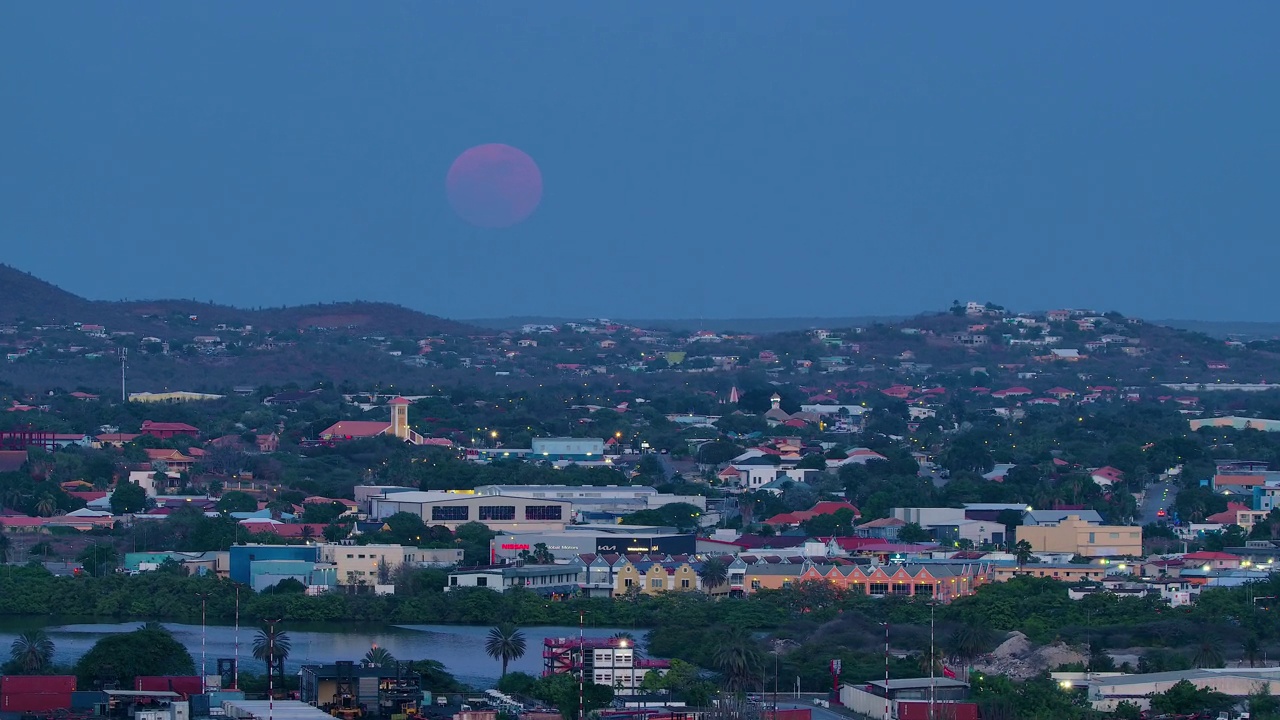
[0,0,1280,320]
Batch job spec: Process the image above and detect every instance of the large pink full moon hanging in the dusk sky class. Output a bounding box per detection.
[444,142,543,228]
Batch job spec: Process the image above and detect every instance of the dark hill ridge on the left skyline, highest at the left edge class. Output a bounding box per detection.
[0,265,479,336]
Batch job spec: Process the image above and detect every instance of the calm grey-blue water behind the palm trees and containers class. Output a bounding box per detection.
[0,618,644,688]
